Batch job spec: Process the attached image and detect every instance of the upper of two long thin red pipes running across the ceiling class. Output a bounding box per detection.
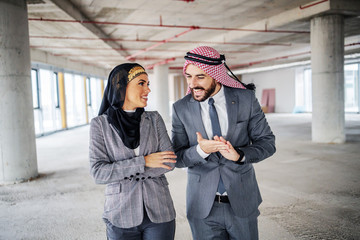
[28,18,310,34]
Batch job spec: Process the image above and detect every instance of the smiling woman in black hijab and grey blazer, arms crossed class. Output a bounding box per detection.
[90,63,176,240]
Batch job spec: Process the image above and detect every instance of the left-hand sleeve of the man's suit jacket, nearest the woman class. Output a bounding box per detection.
[172,105,207,168]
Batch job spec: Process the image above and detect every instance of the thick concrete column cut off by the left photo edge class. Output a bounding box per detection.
[0,0,38,183]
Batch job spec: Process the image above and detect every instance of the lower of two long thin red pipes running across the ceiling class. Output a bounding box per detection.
[30,36,292,47]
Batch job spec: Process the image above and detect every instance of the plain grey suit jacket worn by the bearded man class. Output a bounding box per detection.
[172,86,275,218]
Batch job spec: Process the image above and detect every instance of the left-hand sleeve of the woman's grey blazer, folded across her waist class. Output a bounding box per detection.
[89,118,145,184]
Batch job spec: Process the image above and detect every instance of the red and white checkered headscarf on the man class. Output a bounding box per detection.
[183,46,245,93]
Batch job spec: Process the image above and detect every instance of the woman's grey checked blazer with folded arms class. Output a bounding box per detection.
[89,112,175,228]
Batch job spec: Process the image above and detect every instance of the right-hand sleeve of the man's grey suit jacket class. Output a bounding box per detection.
[236,91,276,163]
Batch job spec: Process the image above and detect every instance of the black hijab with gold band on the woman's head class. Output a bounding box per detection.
[98,63,146,149]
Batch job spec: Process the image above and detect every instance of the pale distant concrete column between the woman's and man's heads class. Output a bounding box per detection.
[150,65,170,123]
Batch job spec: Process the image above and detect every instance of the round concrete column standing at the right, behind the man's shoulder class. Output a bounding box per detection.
[311,15,345,143]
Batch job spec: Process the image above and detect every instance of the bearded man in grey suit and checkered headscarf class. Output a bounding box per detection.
[172,46,275,240]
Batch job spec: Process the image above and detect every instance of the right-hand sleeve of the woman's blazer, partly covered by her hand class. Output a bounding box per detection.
[145,112,175,176]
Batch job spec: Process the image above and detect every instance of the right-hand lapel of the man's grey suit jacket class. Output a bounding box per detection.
[224,87,240,142]
